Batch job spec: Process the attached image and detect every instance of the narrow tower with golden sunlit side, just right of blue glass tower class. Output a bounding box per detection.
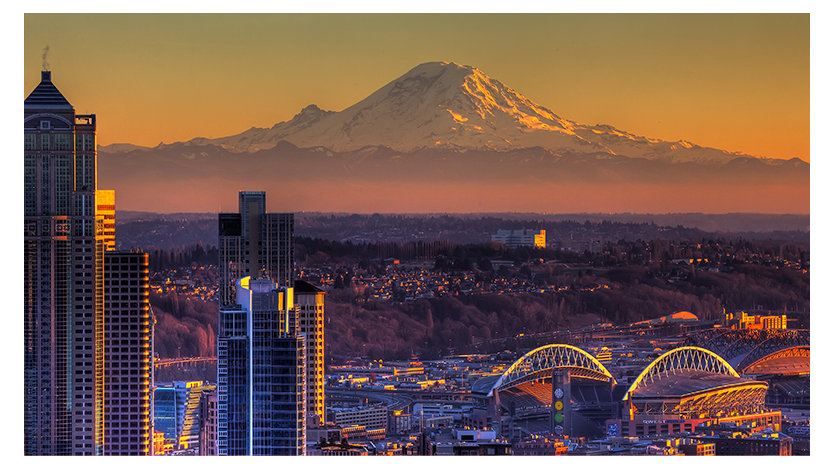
[294,281,325,425]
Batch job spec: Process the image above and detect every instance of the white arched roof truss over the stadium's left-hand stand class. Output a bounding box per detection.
[487,344,616,396]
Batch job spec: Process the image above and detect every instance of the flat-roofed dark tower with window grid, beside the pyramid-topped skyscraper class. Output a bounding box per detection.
[102,251,153,455]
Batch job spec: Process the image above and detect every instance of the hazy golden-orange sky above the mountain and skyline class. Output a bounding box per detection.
[23,14,810,161]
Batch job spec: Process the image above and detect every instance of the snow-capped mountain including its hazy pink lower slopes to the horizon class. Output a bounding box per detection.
[99,62,810,214]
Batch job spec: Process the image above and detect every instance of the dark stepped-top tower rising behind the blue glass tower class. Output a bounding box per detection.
[218,191,295,304]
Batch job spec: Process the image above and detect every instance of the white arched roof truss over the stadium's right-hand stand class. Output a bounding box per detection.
[623,346,739,400]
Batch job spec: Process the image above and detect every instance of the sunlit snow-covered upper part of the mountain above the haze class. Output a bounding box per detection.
[191,62,752,162]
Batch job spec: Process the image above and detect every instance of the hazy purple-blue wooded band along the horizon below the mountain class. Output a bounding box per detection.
[116,212,810,253]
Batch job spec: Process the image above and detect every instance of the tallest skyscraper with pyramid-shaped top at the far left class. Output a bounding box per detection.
[23,71,105,455]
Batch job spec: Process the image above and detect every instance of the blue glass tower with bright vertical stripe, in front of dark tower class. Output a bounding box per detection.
[217,277,306,455]
